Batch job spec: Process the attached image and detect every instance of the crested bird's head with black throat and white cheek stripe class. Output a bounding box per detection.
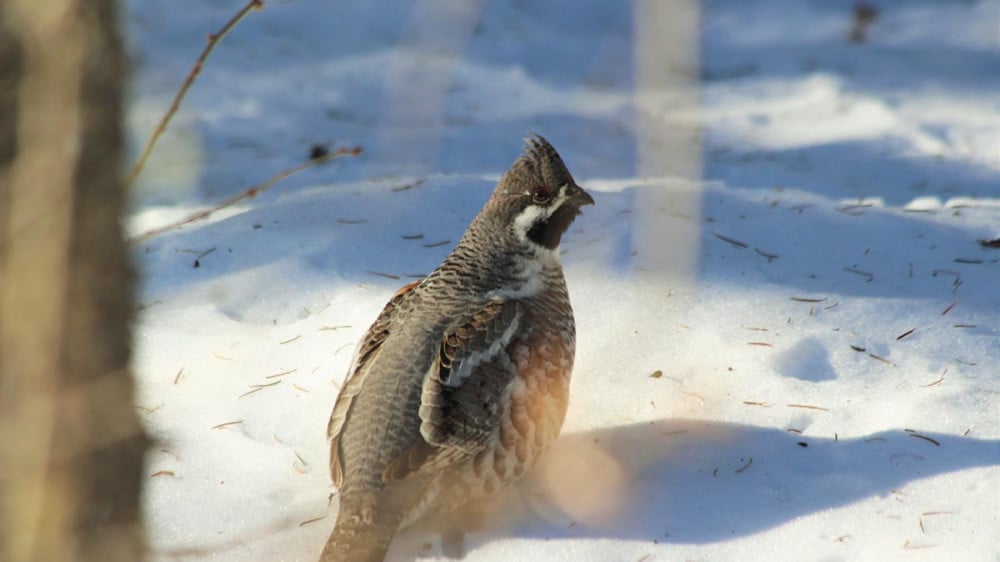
[485,135,594,250]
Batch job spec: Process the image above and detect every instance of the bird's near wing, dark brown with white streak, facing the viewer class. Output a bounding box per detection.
[383,301,525,481]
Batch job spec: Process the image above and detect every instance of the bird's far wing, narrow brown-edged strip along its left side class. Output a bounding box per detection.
[326,281,420,488]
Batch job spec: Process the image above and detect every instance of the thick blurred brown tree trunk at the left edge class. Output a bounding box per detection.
[0,0,146,562]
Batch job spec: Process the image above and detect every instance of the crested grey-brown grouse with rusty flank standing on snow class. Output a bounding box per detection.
[320,135,594,562]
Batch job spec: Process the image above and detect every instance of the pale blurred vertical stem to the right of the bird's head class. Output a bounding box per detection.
[633,0,702,293]
